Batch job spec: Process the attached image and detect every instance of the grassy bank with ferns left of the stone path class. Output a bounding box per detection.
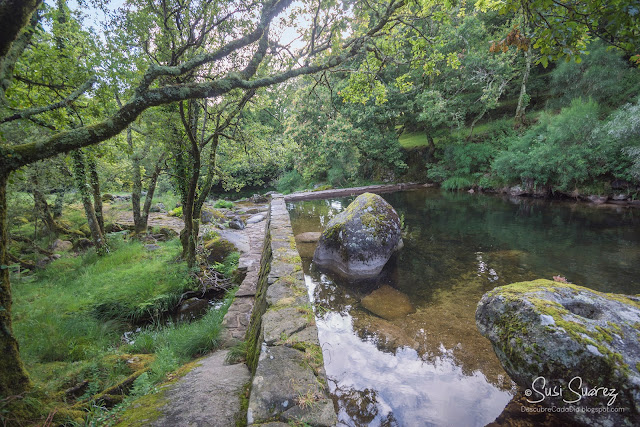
[0,236,237,425]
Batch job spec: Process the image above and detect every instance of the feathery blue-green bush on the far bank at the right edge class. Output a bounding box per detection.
[493,99,638,191]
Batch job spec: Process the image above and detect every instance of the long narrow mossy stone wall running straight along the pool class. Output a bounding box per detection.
[246,194,337,426]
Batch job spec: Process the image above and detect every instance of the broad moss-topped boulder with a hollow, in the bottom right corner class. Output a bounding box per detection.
[476,280,640,426]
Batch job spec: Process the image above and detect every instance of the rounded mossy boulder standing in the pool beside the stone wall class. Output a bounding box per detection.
[313,193,402,280]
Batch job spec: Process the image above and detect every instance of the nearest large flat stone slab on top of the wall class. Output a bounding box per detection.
[247,346,324,424]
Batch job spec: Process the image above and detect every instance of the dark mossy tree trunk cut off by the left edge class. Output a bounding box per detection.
[0,173,31,398]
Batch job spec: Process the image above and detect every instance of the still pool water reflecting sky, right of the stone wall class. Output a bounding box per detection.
[288,189,640,426]
